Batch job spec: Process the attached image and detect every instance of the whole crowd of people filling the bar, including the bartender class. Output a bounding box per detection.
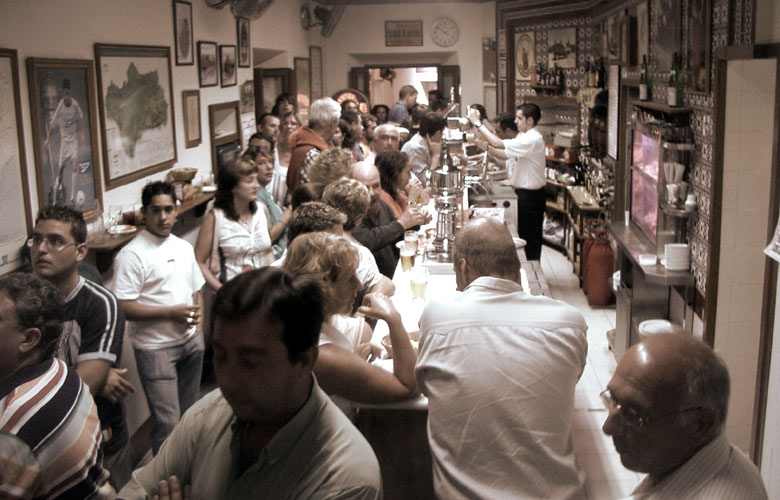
[0,86,766,499]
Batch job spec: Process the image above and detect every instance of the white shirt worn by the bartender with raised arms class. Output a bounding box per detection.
[504,127,547,189]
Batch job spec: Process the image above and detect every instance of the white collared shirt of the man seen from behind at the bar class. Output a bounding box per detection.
[415,276,588,500]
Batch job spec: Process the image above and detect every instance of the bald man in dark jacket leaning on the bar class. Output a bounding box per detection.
[352,162,431,279]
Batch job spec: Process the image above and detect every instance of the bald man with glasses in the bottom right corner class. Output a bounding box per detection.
[601,334,767,500]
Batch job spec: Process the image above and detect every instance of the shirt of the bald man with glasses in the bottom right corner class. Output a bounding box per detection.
[626,434,767,500]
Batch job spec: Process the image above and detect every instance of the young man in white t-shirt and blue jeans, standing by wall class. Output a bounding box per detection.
[114,181,205,454]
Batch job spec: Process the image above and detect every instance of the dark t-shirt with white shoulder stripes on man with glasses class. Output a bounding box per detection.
[57,278,128,455]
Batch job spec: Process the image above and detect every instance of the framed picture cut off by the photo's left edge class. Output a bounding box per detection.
[0,49,33,274]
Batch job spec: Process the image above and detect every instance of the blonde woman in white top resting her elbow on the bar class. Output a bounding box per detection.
[282,232,418,403]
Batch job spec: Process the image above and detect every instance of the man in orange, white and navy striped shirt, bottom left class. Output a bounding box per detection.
[0,273,113,499]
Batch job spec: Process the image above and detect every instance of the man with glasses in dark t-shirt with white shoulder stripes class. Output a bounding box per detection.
[27,206,134,490]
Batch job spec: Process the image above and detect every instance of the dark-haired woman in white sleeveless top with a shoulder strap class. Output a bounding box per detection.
[195,160,274,291]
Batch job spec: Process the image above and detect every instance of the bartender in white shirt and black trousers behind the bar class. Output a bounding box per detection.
[468,103,546,260]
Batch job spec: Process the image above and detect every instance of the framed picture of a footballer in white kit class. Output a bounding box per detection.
[27,58,102,219]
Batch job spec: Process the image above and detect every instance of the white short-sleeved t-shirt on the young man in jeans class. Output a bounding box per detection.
[114,230,205,350]
